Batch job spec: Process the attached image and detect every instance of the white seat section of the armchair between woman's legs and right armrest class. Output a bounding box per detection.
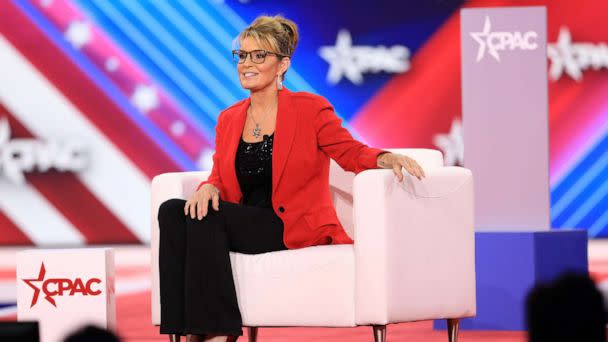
[230,245,355,327]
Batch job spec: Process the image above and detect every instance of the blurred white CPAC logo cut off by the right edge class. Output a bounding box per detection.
[547,27,608,81]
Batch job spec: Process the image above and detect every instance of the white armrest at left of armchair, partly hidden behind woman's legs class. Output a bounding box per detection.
[150,171,211,325]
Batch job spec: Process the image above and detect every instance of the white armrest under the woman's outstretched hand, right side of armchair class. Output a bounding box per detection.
[353,166,476,325]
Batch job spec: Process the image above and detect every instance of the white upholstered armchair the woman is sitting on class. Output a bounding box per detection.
[151,149,476,342]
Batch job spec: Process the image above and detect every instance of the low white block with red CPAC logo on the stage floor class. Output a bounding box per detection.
[17,248,116,342]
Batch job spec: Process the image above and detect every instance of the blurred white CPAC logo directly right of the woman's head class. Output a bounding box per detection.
[319,30,410,85]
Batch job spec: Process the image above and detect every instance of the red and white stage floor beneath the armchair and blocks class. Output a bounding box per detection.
[0,240,608,342]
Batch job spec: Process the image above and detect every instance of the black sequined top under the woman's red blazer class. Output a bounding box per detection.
[234,133,274,208]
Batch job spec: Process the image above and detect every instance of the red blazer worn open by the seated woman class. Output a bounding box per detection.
[197,88,388,249]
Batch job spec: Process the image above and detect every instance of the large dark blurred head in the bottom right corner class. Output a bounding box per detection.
[526,273,606,342]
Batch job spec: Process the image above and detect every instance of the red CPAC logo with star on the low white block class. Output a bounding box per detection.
[22,263,101,308]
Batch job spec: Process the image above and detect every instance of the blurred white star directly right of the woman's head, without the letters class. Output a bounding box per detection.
[319,29,363,84]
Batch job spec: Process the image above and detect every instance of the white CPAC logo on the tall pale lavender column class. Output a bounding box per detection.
[469,16,538,62]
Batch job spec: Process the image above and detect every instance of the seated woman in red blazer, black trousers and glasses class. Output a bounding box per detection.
[158,16,424,341]
